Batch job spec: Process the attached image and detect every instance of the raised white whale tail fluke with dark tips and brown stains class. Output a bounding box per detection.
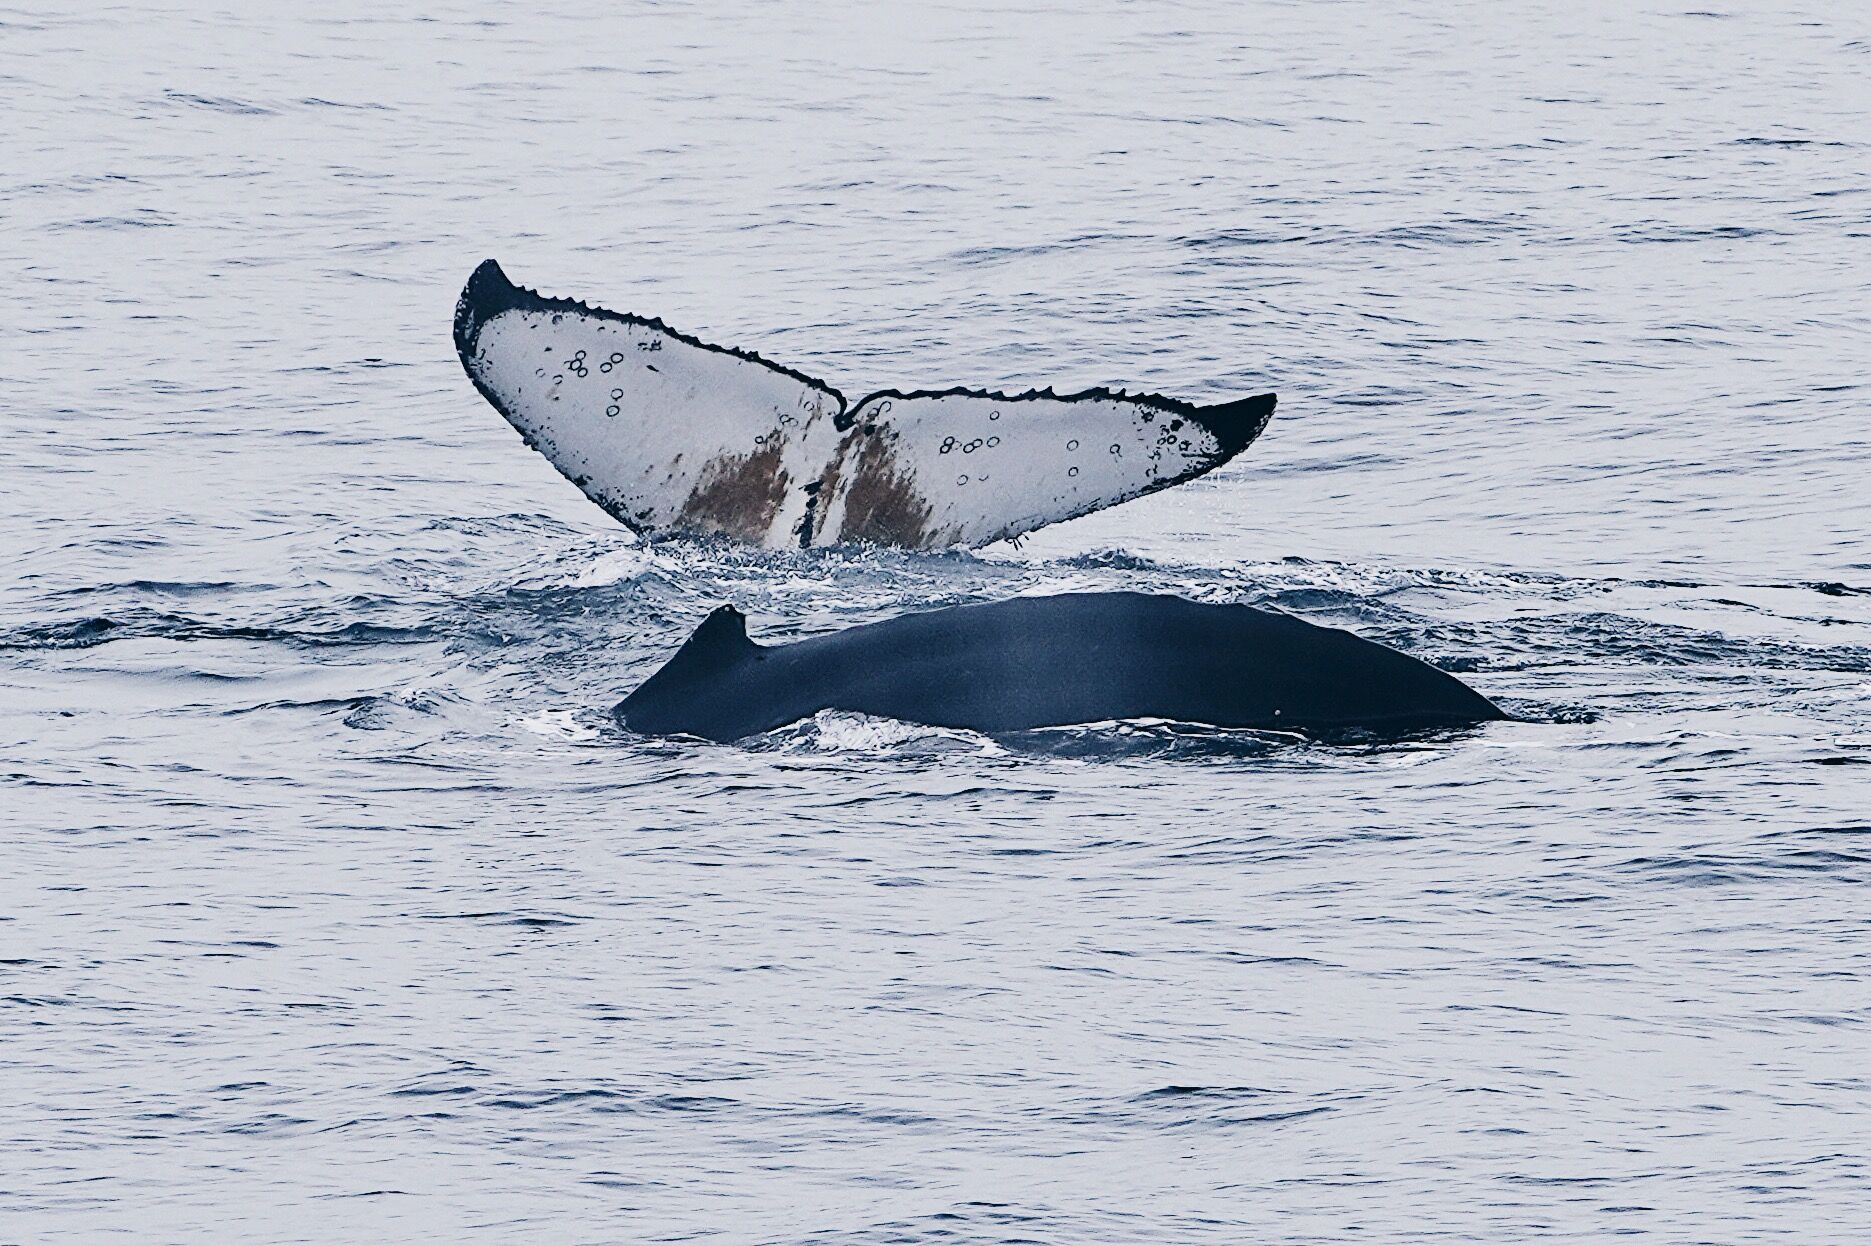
[455,260,1274,548]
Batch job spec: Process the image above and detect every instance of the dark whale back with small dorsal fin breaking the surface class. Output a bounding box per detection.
[617,593,1506,741]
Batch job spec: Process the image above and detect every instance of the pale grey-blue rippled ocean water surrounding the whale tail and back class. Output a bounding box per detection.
[0,0,1871,1246]
